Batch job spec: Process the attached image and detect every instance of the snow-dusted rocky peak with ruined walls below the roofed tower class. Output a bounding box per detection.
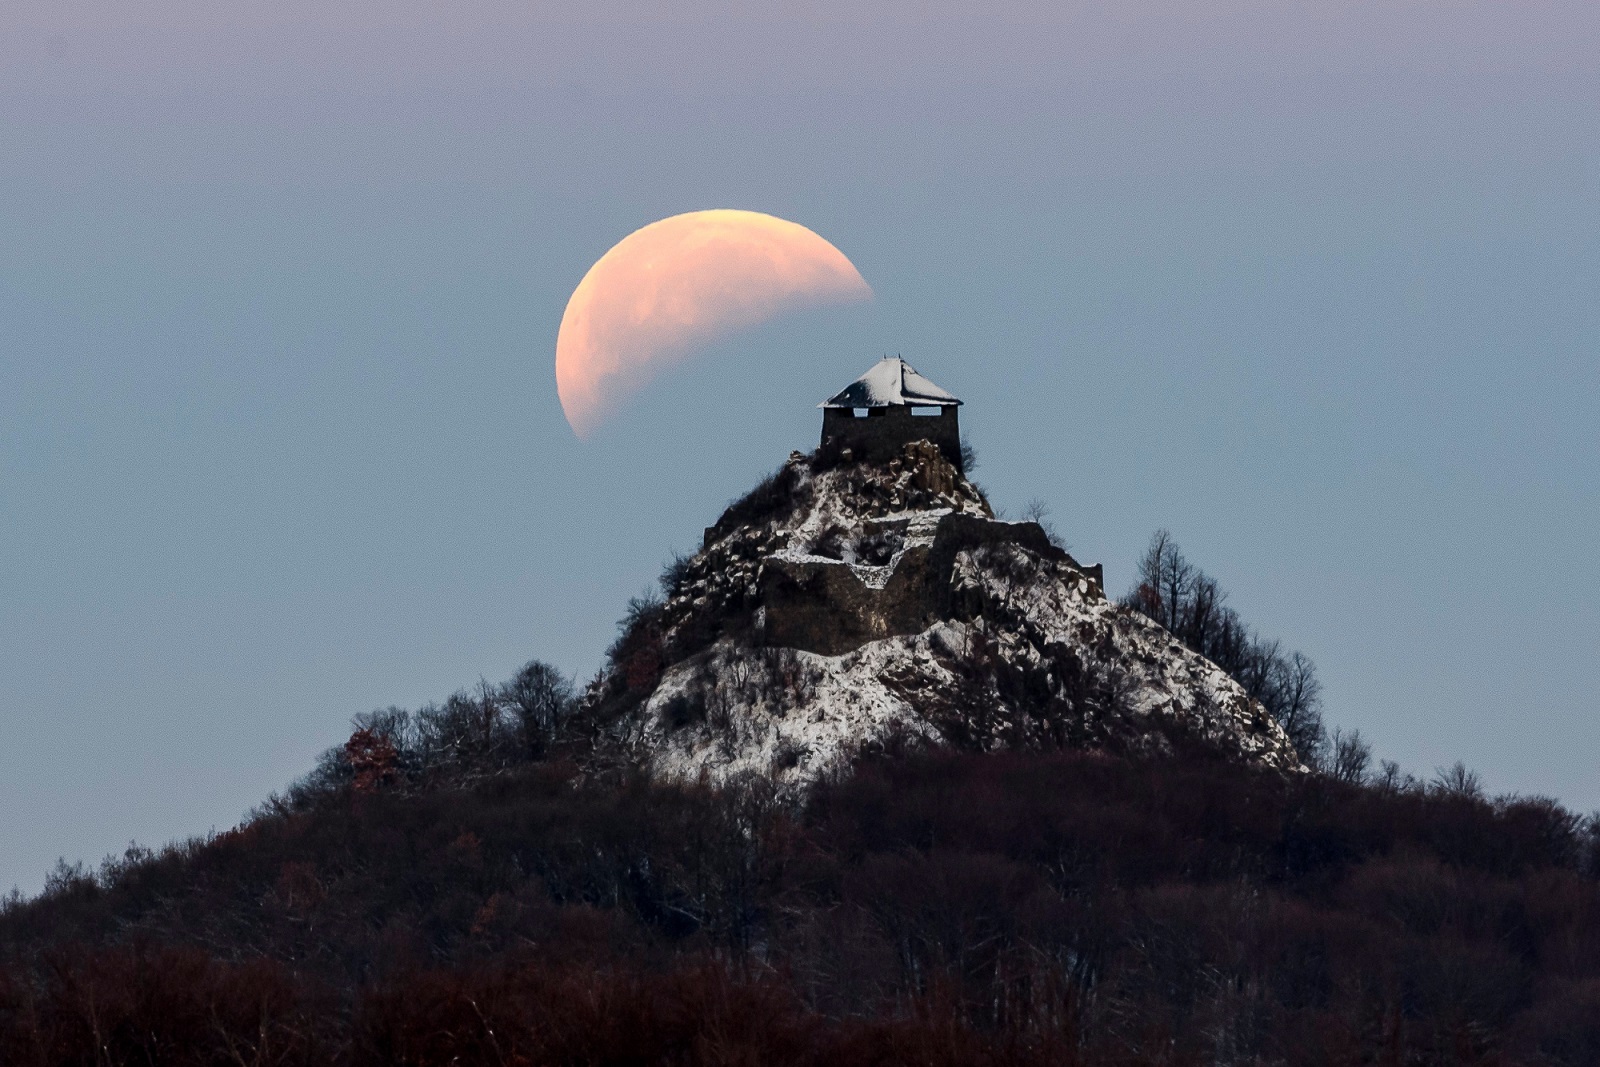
[586,442,1299,787]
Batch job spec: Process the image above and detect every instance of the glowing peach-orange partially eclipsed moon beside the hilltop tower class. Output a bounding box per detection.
[555,210,872,438]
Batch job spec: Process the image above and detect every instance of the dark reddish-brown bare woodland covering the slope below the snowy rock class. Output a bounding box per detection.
[0,752,1600,1067]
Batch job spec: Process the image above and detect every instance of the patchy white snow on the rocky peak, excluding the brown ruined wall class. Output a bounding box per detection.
[611,445,1299,787]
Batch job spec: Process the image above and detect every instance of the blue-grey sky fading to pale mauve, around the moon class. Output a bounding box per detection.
[0,0,1600,893]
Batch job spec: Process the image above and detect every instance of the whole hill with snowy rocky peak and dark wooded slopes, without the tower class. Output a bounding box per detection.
[0,443,1600,1067]
